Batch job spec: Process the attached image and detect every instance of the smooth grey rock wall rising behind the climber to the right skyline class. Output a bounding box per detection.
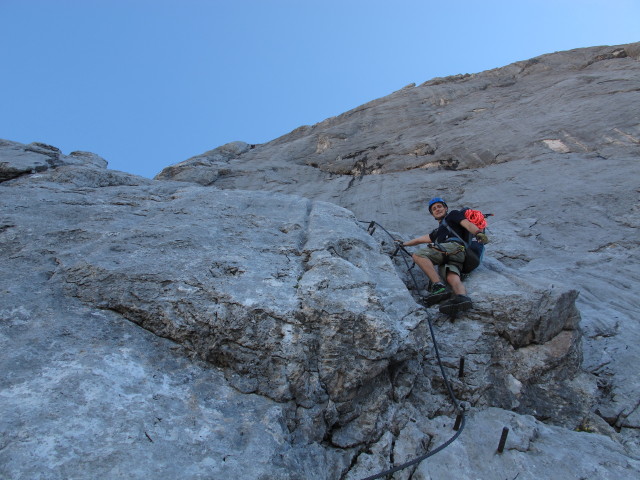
[156,43,640,438]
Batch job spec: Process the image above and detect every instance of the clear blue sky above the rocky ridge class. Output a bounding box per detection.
[0,0,640,178]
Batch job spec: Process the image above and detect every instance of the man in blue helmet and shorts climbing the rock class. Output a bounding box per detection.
[401,197,489,315]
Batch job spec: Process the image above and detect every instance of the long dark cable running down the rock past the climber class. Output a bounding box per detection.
[360,220,465,480]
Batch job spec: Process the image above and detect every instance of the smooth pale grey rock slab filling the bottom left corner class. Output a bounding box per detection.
[0,304,321,479]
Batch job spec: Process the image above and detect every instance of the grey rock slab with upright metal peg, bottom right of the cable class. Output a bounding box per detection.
[413,408,640,480]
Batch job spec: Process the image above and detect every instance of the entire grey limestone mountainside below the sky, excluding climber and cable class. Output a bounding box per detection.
[0,44,640,480]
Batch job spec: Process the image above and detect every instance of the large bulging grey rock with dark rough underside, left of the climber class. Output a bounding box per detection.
[51,187,425,422]
